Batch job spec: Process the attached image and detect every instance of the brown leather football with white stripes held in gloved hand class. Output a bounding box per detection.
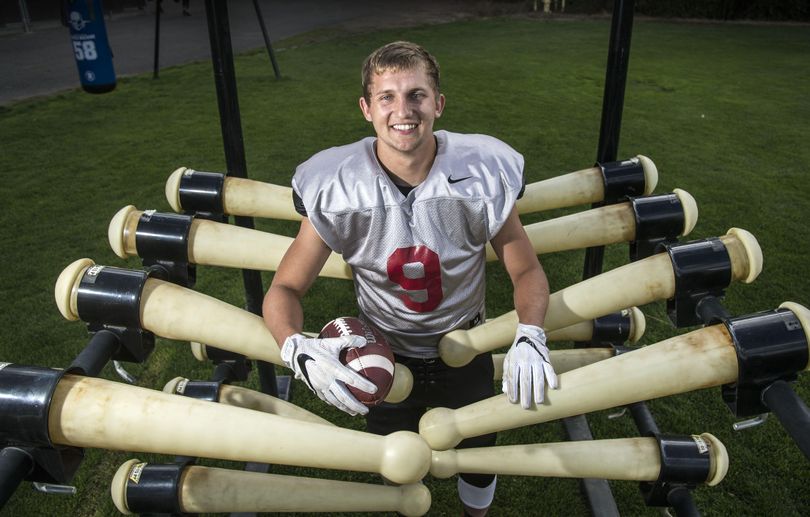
[318,317,394,406]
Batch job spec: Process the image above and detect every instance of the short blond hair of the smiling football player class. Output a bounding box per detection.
[362,41,439,102]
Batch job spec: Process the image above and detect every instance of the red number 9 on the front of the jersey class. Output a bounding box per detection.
[388,246,444,312]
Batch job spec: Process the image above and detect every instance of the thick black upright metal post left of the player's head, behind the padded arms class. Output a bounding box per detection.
[205,0,278,396]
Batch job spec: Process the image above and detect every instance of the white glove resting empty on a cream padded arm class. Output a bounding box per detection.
[503,323,557,409]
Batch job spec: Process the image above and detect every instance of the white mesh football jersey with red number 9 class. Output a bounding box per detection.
[292,131,523,357]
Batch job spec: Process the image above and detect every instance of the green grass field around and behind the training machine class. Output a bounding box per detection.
[0,13,810,516]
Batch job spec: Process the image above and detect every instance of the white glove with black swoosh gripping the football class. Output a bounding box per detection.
[281,334,377,416]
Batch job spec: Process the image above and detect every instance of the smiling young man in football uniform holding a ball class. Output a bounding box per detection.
[264,41,557,515]
